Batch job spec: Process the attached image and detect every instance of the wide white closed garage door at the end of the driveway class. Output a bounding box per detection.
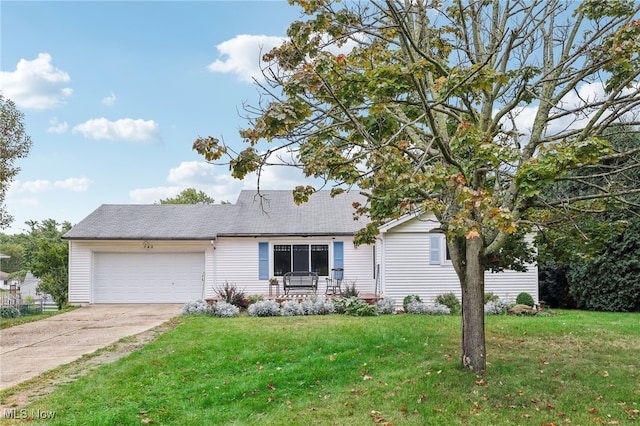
[93,253,204,303]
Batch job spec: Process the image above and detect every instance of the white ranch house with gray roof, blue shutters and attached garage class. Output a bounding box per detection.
[63,191,538,304]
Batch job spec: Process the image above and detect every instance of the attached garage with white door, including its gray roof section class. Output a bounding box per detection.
[63,204,220,305]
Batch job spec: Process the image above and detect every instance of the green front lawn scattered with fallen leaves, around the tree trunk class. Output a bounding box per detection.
[2,311,640,425]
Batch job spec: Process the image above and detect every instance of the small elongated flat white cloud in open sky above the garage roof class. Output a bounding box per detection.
[73,117,160,142]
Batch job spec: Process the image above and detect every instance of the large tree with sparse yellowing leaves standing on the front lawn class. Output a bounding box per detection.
[194,0,640,371]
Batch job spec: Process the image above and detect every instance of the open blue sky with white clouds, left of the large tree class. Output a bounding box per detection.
[0,0,312,233]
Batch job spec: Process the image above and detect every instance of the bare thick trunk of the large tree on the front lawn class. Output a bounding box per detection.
[459,237,487,372]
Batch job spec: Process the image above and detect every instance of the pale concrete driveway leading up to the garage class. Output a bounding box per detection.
[0,304,184,390]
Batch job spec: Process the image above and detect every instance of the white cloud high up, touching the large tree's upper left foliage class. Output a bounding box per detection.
[207,34,285,82]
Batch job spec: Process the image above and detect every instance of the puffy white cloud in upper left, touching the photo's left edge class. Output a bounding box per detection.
[0,53,73,110]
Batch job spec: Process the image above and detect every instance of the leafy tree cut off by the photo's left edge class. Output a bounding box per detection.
[0,94,31,229]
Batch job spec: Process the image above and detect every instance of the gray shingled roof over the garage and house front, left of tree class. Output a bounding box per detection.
[63,190,366,240]
